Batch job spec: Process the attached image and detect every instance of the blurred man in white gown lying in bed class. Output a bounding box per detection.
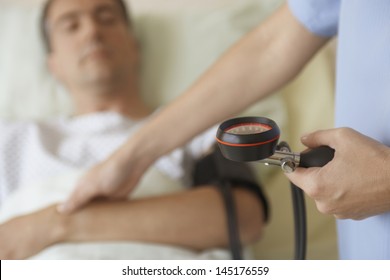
[0,0,266,259]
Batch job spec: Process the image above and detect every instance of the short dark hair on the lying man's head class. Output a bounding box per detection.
[40,0,131,53]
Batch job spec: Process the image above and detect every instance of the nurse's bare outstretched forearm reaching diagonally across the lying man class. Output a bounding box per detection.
[119,5,327,162]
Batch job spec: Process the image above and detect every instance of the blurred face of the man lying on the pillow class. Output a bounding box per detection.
[47,0,138,87]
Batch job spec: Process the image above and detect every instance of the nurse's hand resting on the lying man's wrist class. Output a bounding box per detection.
[57,143,153,214]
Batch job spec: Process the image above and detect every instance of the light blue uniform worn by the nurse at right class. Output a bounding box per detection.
[289,0,390,259]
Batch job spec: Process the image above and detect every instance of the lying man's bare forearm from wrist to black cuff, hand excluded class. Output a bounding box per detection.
[58,187,263,249]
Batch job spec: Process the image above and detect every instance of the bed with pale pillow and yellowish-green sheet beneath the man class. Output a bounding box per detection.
[0,0,337,259]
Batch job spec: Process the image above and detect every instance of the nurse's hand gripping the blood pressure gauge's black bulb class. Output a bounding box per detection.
[287,128,390,220]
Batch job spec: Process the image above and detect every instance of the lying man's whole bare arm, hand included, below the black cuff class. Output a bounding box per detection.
[0,187,264,259]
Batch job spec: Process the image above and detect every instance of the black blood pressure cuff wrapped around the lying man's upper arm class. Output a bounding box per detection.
[192,146,269,221]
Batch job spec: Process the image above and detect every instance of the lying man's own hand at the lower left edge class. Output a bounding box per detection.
[0,206,63,260]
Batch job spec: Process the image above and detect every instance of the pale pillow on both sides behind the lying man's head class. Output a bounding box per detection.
[0,0,284,122]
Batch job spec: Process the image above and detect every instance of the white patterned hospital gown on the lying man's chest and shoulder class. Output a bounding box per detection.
[0,112,215,206]
